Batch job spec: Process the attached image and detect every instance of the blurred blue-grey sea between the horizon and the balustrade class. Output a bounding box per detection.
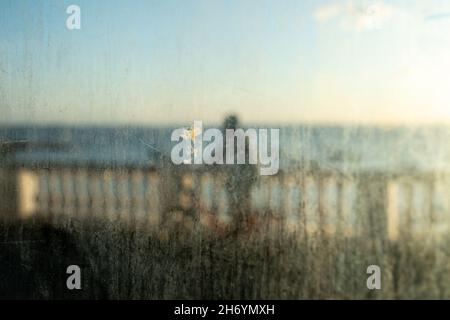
[0,125,450,172]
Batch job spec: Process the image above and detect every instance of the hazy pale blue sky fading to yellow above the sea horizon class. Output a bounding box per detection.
[0,0,450,124]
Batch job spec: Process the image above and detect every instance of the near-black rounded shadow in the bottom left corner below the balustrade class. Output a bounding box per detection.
[0,221,107,299]
